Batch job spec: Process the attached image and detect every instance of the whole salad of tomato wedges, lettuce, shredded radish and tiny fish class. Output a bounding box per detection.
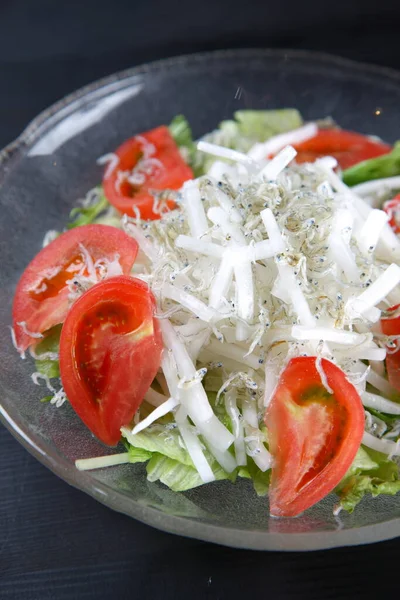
[12,109,400,517]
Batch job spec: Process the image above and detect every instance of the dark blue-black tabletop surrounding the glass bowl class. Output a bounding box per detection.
[0,0,400,600]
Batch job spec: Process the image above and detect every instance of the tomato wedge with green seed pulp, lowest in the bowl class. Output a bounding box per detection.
[265,357,364,517]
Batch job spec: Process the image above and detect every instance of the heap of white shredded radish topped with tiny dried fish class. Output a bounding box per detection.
[77,123,400,482]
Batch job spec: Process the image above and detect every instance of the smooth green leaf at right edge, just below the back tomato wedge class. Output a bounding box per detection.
[343,142,400,186]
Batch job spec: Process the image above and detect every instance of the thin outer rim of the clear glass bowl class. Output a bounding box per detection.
[0,48,400,551]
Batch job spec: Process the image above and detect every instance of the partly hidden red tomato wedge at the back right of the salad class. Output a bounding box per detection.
[294,129,392,169]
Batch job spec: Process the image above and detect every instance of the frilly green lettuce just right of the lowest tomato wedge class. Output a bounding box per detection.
[335,446,400,512]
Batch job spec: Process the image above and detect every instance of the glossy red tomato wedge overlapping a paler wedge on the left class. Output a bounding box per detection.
[60,275,163,446]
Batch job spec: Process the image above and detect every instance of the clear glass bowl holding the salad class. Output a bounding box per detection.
[0,50,400,550]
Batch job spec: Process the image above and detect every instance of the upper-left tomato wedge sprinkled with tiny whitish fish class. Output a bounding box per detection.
[103,125,193,219]
